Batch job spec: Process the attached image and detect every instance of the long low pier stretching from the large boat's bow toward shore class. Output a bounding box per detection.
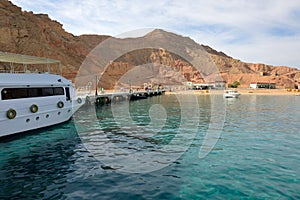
[85,90,165,106]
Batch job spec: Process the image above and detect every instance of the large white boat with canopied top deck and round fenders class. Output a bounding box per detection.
[0,52,85,137]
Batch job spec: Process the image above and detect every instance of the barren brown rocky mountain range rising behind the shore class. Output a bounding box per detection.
[0,0,300,88]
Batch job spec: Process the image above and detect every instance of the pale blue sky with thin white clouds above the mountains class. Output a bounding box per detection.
[11,0,300,69]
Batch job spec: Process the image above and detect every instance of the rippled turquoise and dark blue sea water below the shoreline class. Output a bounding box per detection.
[0,95,300,199]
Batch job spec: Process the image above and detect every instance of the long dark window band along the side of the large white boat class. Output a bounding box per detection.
[1,87,64,100]
